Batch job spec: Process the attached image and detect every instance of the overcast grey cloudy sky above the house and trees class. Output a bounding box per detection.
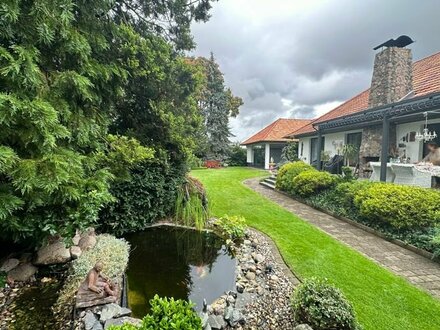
[193,0,440,141]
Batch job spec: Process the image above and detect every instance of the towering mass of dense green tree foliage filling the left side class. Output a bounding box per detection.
[0,0,220,240]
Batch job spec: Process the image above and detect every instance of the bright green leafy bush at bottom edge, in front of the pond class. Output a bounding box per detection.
[109,295,202,330]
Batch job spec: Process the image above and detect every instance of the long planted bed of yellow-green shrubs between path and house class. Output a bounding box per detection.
[277,161,440,256]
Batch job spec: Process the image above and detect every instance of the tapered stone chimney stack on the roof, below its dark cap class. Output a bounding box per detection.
[368,47,413,108]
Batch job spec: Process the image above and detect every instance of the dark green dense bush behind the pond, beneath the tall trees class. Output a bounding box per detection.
[99,161,185,236]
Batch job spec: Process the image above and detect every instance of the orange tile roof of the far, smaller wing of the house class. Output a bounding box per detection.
[242,118,311,145]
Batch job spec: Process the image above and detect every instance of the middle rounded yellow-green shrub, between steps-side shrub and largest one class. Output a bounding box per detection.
[292,170,338,197]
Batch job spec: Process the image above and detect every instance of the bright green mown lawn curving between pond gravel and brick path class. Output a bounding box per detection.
[191,168,440,330]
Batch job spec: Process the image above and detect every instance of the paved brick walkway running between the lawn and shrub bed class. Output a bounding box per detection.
[244,179,440,298]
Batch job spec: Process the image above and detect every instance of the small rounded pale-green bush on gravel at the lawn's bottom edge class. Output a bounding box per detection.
[292,278,361,330]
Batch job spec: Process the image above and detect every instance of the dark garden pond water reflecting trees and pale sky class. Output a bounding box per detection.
[127,226,235,317]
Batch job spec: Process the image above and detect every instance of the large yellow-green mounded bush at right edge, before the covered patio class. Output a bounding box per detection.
[354,183,440,228]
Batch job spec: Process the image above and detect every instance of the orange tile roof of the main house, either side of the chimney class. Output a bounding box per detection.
[288,52,440,136]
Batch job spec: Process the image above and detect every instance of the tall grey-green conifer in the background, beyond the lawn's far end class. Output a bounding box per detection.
[195,53,243,159]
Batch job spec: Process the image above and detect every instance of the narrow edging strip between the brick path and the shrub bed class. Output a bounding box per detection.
[266,183,440,263]
